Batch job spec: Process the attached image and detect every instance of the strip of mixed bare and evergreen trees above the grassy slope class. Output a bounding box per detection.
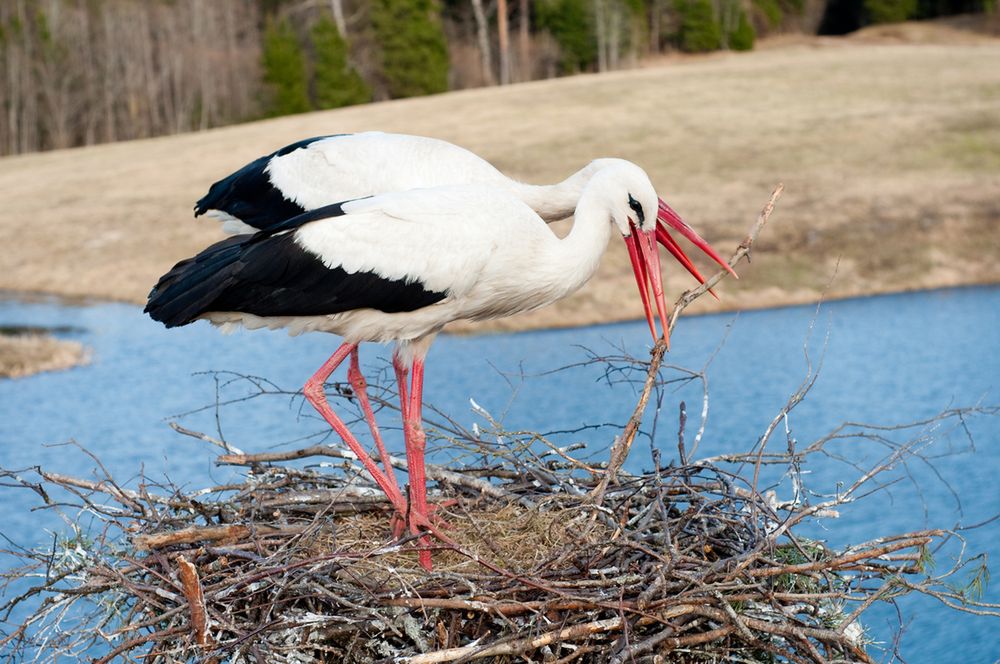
[0,0,996,155]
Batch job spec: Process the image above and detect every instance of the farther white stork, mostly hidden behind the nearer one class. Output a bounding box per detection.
[195,131,738,296]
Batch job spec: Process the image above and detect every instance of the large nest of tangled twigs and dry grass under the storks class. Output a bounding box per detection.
[0,189,996,664]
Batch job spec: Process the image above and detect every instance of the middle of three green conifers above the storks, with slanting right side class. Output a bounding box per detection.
[311,18,372,108]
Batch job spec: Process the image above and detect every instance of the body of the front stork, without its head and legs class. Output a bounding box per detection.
[167,184,608,343]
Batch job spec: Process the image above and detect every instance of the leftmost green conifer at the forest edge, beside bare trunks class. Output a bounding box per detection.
[261,21,310,116]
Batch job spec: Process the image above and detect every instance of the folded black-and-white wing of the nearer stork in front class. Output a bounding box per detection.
[146,187,544,327]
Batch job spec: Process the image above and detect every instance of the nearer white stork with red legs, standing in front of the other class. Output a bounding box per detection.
[145,160,704,569]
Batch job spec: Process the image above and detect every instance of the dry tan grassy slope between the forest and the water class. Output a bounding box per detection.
[0,27,1000,328]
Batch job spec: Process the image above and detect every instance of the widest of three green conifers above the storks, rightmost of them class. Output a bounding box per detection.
[371,0,448,97]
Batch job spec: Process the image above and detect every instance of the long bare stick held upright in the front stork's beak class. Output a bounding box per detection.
[590,184,784,505]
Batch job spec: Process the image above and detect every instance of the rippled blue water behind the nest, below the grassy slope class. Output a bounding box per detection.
[0,287,1000,663]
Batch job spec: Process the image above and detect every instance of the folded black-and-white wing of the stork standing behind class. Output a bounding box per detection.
[195,132,506,232]
